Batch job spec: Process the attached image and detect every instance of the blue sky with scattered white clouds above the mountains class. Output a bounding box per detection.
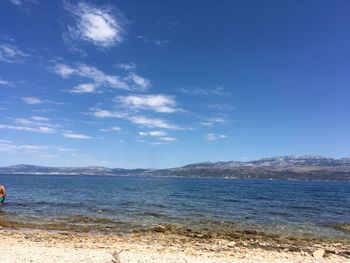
[0,0,350,168]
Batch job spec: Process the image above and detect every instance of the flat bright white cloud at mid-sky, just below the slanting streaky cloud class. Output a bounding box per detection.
[116,95,178,113]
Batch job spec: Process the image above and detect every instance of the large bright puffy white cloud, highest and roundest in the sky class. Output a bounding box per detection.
[64,1,124,48]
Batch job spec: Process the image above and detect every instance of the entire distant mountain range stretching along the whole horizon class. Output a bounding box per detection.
[0,156,350,181]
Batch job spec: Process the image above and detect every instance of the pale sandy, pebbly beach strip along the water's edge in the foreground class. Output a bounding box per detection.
[0,229,350,263]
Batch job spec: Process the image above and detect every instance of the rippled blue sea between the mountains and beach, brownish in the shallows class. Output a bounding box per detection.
[0,175,350,239]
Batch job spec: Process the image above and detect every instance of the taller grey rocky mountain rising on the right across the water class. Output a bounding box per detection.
[150,156,350,181]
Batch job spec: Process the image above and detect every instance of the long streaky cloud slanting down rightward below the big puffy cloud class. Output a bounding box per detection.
[54,63,129,90]
